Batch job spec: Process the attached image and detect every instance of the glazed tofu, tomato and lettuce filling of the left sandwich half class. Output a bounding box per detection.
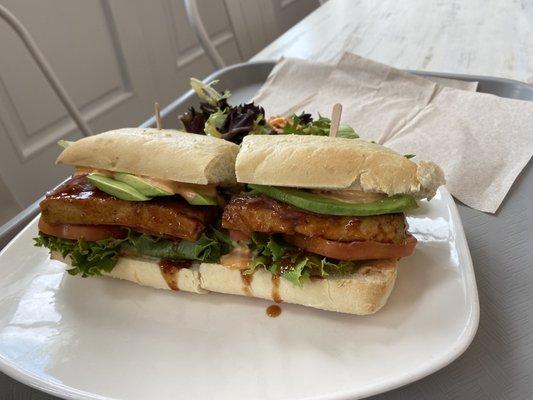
[36,172,231,276]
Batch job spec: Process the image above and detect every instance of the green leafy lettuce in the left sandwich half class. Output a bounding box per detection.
[35,228,233,277]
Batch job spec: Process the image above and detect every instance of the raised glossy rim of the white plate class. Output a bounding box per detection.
[0,186,480,400]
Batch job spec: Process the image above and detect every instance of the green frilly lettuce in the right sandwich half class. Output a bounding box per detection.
[245,233,361,287]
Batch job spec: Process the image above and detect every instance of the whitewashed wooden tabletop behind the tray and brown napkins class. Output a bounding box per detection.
[252,0,533,83]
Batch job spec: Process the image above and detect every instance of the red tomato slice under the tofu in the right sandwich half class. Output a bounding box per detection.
[285,235,416,261]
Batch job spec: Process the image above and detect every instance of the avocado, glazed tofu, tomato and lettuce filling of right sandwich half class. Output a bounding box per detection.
[221,185,416,286]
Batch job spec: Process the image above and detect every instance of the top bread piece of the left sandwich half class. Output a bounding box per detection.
[56,128,239,185]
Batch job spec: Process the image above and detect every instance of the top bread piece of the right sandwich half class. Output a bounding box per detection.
[235,135,445,198]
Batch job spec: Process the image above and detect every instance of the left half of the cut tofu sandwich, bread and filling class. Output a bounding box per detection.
[36,128,239,293]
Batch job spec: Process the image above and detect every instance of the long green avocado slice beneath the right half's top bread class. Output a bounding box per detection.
[248,184,418,216]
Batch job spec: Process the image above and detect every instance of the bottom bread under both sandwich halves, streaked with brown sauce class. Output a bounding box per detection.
[51,252,398,315]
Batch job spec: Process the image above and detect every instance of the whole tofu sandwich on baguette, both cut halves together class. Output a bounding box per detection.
[36,128,445,315]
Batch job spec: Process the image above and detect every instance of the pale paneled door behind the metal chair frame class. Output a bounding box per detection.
[0,0,241,224]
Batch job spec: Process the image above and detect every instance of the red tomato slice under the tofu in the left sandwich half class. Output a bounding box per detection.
[39,217,127,242]
